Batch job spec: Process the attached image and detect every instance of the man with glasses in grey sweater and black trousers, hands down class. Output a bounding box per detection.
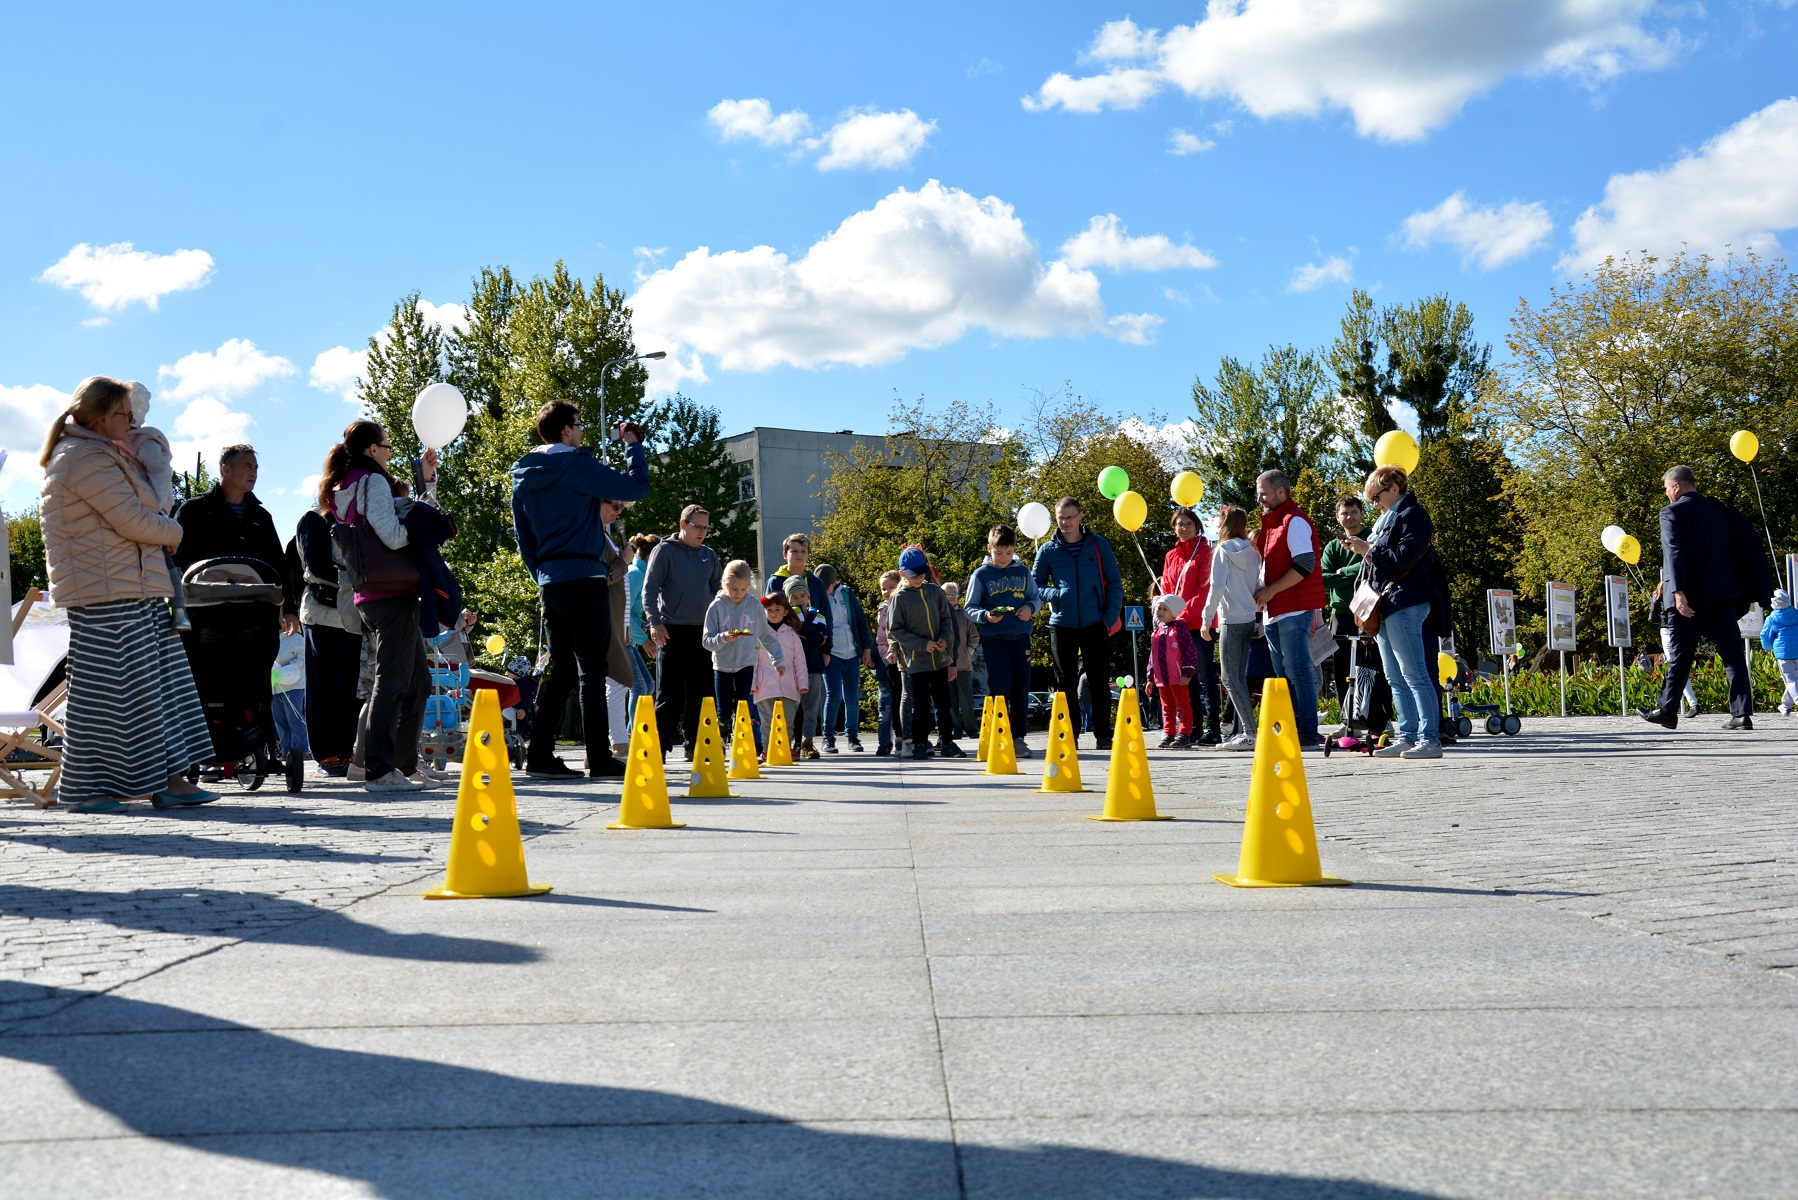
[644,504,726,763]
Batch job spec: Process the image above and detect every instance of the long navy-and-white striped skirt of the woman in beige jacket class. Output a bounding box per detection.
[61,599,212,802]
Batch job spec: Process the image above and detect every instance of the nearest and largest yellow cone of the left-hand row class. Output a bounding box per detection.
[424,691,550,900]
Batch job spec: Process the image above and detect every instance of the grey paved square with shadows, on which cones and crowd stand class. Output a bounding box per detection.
[0,718,1798,1198]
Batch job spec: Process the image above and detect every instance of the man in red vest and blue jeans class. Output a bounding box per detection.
[1255,471,1323,750]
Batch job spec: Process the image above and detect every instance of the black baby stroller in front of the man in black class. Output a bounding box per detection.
[182,556,306,792]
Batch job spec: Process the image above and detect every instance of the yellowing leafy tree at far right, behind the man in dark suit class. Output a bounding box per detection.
[1482,254,1798,649]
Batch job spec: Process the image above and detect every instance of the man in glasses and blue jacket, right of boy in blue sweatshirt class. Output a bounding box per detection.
[1030,497,1124,750]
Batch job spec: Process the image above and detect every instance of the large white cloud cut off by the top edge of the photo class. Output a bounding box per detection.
[1023,0,1681,140]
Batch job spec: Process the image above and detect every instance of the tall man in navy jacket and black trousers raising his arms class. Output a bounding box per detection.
[512,399,649,779]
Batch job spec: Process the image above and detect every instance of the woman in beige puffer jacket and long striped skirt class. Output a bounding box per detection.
[40,376,218,813]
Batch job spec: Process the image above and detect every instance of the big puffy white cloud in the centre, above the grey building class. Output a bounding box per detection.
[631,180,1160,389]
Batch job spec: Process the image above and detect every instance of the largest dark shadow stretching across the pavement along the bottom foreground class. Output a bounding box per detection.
[0,982,1428,1200]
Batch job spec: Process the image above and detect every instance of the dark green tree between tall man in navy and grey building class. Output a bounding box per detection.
[624,396,755,563]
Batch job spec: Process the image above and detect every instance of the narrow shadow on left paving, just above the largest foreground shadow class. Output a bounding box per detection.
[0,883,541,963]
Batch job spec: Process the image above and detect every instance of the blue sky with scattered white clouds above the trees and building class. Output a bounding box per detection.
[0,0,1798,525]
